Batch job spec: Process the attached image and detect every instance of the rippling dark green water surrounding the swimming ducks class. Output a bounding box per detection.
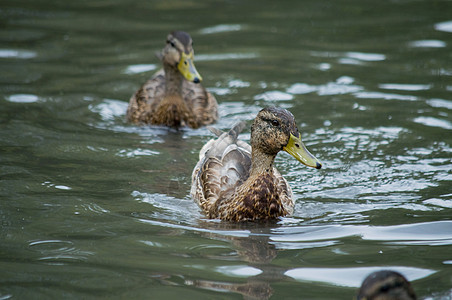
[0,0,452,299]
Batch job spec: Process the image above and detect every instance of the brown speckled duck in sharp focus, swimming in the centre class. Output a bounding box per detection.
[191,107,322,221]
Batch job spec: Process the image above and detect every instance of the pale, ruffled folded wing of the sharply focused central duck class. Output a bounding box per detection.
[191,122,251,214]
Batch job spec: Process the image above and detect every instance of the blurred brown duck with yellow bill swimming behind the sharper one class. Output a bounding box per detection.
[127,31,218,128]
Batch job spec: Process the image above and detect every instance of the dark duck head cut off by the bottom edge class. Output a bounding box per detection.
[357,270,416,300]
